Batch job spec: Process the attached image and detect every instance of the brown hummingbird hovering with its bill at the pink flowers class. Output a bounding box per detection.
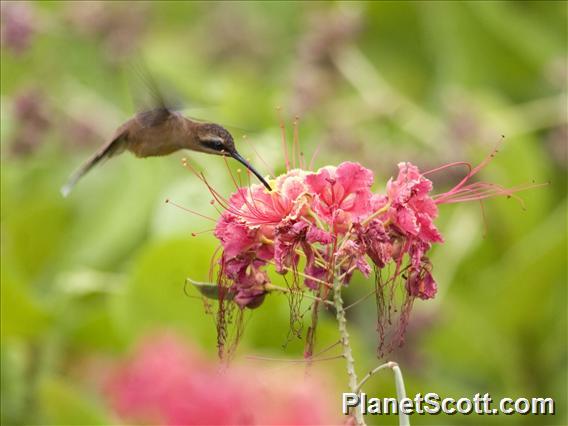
[61,75,271,197]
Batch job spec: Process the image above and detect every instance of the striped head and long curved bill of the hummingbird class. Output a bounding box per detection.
[196,123,272,191]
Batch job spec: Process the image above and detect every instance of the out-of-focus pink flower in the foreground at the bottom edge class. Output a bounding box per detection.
[106,335,338,426]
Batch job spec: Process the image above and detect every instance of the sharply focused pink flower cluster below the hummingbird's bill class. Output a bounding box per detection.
[215,162,443,308]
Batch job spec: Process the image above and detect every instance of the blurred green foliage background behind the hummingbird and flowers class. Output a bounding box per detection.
[1,1,568,425]
